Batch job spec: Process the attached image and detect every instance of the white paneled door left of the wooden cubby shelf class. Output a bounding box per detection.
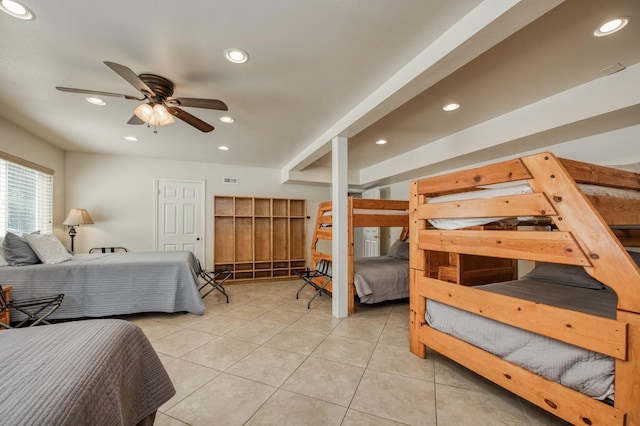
[156,179,205,264]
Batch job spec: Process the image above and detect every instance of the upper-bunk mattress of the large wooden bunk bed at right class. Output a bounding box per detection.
[427,183,640,229]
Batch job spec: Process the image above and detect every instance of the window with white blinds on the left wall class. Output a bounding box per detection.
[0,152,53,236]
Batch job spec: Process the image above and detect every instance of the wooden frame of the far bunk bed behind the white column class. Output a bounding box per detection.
[311,197,409,314]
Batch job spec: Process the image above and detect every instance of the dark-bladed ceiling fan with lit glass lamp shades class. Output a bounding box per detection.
[56,61,227,132]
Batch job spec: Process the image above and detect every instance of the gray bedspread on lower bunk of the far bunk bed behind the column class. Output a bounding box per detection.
[353,256,409,303]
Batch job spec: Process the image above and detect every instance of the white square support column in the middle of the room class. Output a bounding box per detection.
[331,136,349,318]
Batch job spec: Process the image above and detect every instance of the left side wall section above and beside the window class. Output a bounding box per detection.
[0,117,69,241]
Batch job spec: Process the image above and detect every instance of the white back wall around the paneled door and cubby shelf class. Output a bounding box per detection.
[65,152,329,268]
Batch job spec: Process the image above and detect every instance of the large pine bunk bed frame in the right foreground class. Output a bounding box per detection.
[410,153,640,425]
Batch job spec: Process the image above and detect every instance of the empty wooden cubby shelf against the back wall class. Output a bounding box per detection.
[213,196,307,281]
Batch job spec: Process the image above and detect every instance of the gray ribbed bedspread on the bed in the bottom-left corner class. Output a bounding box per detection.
[0,319,175,426]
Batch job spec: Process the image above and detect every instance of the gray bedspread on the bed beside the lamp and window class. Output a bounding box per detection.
[0,251,204,321]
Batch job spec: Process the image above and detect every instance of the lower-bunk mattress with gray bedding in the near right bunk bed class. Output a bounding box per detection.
[426,262,624,400]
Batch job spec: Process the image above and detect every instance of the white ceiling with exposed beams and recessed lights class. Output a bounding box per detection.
[0,0,640,190]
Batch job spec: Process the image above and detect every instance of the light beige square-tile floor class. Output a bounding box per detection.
[127,280,565,426]
